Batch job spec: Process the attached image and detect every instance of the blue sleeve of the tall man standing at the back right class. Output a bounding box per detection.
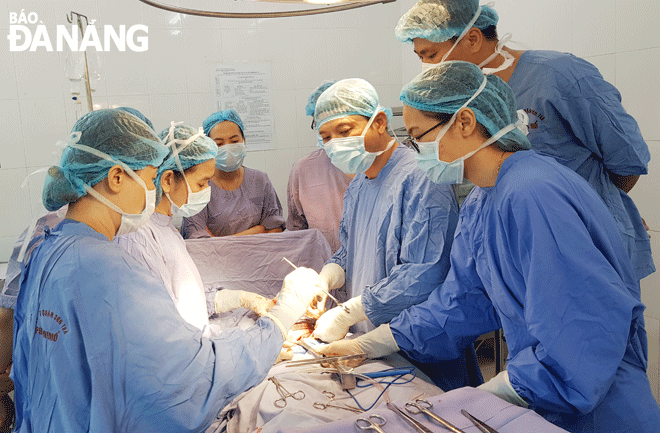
[552,71,651,176]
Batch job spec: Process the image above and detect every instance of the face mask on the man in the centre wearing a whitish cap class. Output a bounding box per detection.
[319,107,396,174]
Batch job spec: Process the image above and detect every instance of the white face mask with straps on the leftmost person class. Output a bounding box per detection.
[69,140,156,236]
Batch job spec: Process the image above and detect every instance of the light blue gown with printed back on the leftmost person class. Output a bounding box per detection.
[11,220,283,433]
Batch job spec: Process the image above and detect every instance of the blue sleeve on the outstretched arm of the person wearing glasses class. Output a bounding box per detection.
[390,219,501,363]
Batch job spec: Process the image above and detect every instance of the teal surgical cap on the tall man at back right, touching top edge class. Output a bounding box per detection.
[394,0,499,42]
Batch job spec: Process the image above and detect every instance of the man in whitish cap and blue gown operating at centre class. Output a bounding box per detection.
[306,79,483,390]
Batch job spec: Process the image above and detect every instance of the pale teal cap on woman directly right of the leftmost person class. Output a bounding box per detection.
[154,125,218,201]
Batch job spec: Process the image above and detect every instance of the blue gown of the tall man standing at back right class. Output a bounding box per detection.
[508,51,655,280]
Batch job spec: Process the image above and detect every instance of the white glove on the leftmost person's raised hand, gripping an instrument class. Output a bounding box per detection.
[264,267,321,340]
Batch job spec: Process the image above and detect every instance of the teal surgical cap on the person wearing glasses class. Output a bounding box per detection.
[399,61,531,151]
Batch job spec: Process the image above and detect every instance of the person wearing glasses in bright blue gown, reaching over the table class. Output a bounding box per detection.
[326,62,660,433]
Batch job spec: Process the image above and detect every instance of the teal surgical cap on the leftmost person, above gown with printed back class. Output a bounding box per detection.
[42,109,167,211]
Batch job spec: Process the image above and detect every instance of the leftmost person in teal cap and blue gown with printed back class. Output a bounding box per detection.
[11,110,318,433]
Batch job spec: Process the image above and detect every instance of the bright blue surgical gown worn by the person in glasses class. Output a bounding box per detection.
[390,151,660,433]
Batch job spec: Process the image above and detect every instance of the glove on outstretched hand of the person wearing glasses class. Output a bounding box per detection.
[316,323,399,367]
